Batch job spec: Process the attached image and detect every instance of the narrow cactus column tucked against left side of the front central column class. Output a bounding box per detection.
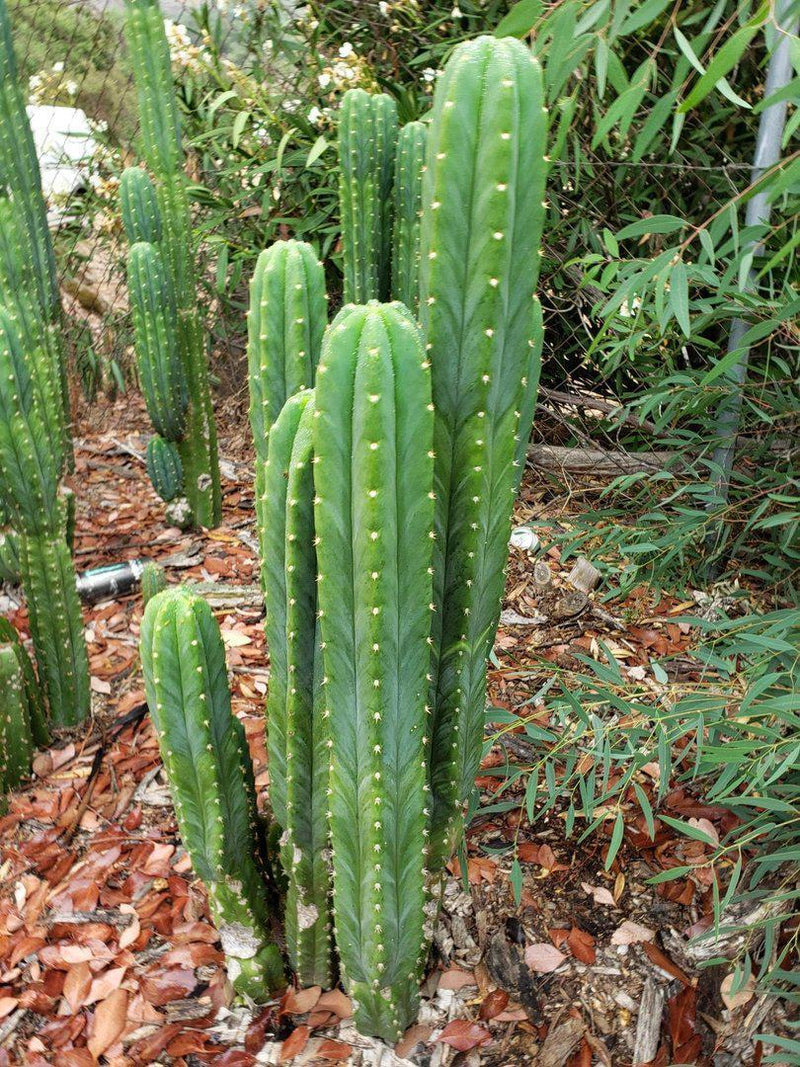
[262,389,332,986]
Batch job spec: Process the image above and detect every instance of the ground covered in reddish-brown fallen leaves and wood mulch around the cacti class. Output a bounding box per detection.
[0,398,789,1067]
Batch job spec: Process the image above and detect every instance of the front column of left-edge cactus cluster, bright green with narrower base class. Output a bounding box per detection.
[0,309,90,726]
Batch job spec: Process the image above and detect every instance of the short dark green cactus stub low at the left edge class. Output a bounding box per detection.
[0,618,49,793]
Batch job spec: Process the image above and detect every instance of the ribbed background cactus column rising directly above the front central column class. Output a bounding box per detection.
[339,89,397,304]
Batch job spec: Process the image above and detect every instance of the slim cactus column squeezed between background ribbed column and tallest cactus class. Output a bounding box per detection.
[391,123,428,315]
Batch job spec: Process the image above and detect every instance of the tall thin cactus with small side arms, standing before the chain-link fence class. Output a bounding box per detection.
[121,0,221,527]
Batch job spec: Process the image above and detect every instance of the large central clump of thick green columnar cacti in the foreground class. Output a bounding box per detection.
[143,31,546,1040]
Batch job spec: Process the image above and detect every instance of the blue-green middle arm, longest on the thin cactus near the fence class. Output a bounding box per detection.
[128,241,189,441]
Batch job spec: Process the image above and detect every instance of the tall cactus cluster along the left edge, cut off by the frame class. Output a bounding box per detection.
[0,0,90,725]
